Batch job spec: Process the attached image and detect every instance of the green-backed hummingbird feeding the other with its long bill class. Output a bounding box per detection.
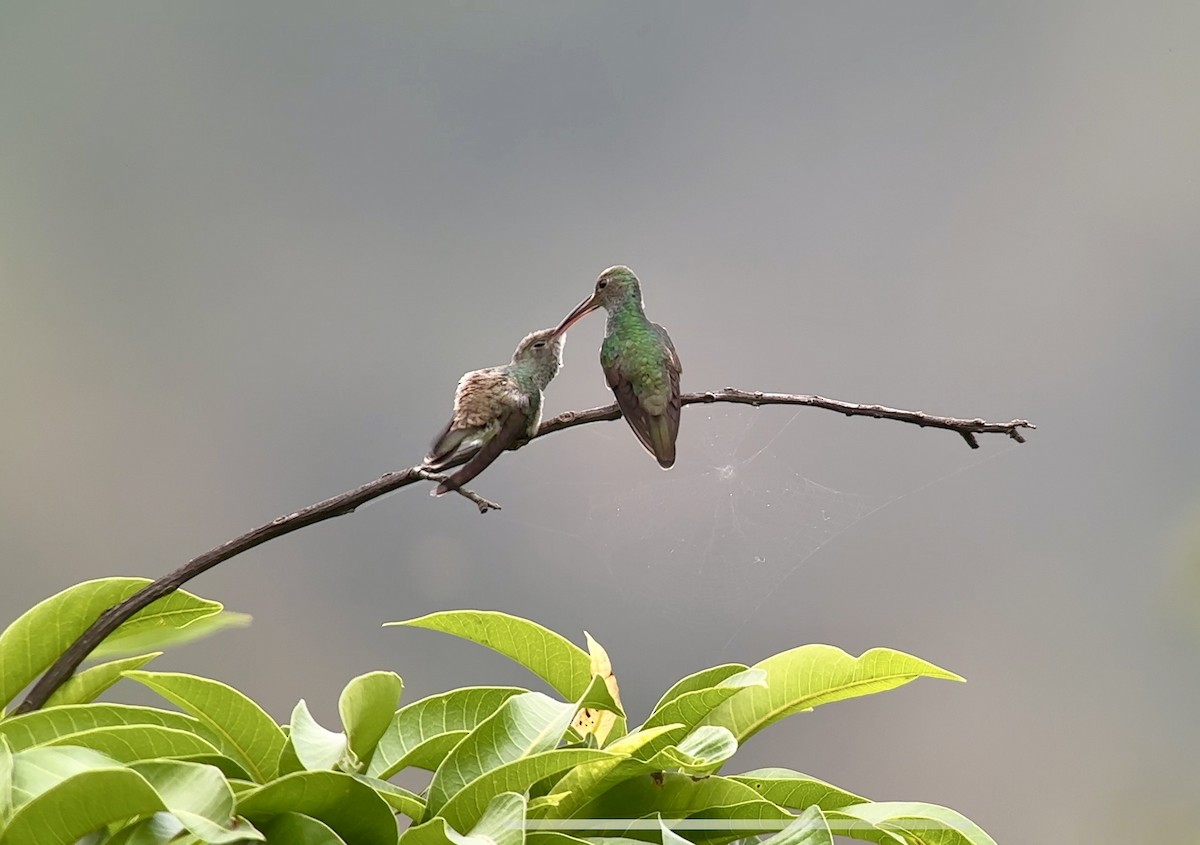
[554,265,683,469]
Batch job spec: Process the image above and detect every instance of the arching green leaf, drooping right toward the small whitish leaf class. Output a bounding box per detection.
[126,670,284,783]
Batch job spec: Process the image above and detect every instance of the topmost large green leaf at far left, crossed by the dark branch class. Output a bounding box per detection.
[0,577,221,706]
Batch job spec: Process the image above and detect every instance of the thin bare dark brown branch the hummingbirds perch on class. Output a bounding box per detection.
[14,388,1037,713]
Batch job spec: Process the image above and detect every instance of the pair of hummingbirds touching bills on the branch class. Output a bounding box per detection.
[425,265,683,496]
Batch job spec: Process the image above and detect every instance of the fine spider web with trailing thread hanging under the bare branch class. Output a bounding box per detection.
[511,408,1003,652]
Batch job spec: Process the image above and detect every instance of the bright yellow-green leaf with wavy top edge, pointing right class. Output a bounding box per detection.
[702,646,962,743]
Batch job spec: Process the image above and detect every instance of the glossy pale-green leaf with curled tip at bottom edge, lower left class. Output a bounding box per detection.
[130,760,264,845]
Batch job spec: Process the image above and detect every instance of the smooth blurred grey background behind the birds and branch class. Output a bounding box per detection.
[0,0,1200,843]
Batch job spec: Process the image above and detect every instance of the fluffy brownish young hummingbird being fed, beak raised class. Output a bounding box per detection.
[424,329,565,496]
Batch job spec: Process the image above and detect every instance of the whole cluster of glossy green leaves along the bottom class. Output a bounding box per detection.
[0,579,992,845]
